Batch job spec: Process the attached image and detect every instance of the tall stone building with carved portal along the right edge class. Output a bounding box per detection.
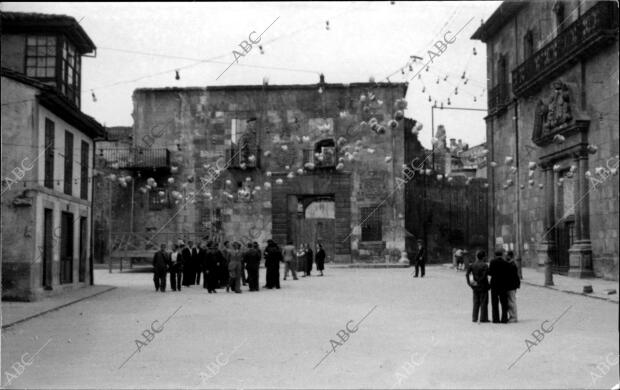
[473,1,618,280]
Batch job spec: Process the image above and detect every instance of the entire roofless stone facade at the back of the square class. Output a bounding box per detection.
[98,79,414,263]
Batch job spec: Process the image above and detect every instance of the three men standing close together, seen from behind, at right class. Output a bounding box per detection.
[465,249,521,323]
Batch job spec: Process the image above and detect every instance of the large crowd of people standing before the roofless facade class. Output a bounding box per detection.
[153,240,326,294]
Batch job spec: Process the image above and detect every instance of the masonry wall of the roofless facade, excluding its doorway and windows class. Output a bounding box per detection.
[99,83,406,261]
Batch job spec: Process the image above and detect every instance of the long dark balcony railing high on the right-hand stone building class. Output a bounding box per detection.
[512,1,618,96]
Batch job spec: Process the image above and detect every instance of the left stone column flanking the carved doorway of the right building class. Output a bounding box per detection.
[537,164,556,286]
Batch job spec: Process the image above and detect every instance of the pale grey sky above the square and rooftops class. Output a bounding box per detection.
[0,1,500,147]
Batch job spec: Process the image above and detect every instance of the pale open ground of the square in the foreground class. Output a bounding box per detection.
[2,266,618,389]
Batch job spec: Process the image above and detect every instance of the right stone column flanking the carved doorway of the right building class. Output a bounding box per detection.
[568,150,594,278]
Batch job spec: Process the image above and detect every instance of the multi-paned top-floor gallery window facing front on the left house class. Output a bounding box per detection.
[26,35,56,80]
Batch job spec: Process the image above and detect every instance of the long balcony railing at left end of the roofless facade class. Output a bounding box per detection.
[97,148,170,169]
